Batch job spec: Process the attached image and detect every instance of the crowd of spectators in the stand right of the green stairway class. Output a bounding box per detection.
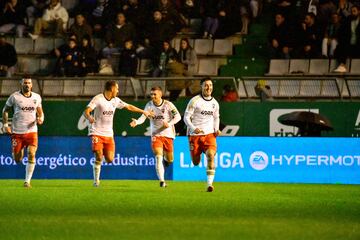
[269,0,360,72]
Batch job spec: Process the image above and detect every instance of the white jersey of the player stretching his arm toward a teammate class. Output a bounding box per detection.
[88,93,128,137]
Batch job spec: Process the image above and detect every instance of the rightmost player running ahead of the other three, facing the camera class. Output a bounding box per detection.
[184,77,221,192]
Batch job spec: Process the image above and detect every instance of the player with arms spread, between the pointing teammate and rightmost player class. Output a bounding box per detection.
[130,87,181,187]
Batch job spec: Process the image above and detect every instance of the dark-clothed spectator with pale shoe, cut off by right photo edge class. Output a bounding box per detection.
[334,6,360,73]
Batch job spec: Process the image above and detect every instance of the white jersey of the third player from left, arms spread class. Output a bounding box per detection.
[136,100,181,138]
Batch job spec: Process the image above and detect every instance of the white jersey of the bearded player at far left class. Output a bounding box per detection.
[6,91,41,134]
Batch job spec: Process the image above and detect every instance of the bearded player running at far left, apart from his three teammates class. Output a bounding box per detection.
[2,76,44,188]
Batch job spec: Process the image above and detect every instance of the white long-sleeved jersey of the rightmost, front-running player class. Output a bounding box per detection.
[184,94,220,136]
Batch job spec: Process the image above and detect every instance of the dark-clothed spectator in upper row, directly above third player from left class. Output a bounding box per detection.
[145,10,175,56]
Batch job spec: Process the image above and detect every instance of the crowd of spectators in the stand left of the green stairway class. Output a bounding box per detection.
[0,0,262,76]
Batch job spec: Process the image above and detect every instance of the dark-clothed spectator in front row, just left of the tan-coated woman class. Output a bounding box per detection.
[152,40,178,77]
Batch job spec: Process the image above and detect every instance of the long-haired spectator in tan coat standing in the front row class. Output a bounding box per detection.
[179,38,197,76]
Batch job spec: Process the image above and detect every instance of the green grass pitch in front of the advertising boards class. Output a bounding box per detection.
[0,180,360,240]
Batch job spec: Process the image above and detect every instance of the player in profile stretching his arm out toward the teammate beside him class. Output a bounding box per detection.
[84,80,153,187]
